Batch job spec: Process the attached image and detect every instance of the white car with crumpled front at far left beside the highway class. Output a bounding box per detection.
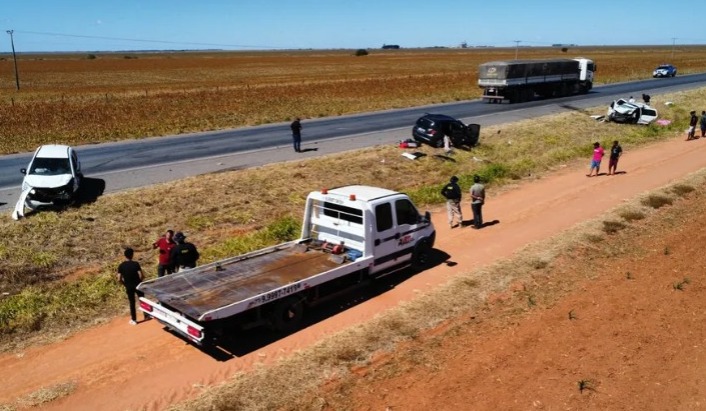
[12,144,83,220]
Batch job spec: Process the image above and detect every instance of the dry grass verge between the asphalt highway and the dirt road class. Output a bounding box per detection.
[0,86,703,349]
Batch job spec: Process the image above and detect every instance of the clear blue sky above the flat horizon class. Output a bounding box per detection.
[0,0,706,53]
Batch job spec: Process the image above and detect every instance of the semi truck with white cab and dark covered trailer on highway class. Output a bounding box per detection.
[478,57,596,103]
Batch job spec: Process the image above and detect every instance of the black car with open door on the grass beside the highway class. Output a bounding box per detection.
[412,114,480,147]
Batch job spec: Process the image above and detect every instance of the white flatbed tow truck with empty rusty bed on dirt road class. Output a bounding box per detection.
[138,185,436,346]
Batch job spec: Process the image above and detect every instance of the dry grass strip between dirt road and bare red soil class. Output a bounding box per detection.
[172,166,706,410]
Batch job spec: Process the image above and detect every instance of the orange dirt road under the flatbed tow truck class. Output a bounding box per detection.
[0,137,706,410]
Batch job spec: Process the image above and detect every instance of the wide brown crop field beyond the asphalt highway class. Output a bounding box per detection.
[0,46,706,154]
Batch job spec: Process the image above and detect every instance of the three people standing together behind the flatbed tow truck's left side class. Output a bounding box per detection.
[118,230,199,325]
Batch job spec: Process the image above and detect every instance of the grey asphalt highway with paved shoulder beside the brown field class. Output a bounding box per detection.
[0,74,706,209]
